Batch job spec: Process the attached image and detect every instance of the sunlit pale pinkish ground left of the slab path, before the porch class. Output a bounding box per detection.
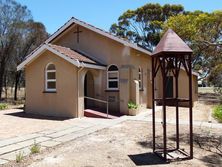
[0,109,84,140]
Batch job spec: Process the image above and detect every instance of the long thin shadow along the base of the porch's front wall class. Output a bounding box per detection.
[5,111,71,121]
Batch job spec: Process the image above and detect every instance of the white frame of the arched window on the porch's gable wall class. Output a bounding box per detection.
[45,63,56,92]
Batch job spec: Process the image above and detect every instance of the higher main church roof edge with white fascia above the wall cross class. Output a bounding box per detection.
[46,17,151,55]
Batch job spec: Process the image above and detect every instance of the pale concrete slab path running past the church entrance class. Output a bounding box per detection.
[0,110,222,165]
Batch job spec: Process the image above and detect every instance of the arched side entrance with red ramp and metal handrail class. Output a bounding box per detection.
[78,68,120,119]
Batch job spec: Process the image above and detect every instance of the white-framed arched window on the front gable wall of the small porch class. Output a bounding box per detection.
[45,63,56,92]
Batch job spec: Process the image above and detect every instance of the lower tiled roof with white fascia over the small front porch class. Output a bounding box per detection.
[17,44,106,70]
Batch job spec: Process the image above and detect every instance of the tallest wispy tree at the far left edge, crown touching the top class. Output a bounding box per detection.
[0,0,32,100]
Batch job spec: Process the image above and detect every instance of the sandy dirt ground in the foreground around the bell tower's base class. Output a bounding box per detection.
[4,121,222,167]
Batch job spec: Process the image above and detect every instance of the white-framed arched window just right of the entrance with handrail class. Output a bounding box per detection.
[107,65,119,90]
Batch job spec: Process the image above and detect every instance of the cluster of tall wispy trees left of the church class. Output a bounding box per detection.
[0,0,48,100]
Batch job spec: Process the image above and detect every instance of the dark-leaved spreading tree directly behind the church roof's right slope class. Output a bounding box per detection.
[110,3,184,50]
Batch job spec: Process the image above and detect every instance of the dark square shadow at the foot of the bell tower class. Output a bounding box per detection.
[128,153,167,166]
